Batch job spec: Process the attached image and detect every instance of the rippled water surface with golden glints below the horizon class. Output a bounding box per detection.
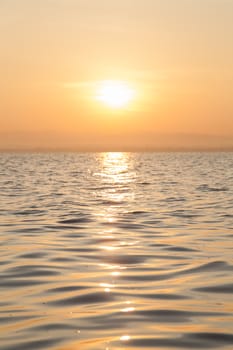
[0,153,233,350]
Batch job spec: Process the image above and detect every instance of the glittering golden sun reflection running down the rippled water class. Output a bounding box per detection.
[95,152,136,342]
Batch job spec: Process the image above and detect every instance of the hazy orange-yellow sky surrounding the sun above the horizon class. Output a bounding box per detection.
[0,0,233,151]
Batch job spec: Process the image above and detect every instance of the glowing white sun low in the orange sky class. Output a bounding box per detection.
[96,80,135,109]
